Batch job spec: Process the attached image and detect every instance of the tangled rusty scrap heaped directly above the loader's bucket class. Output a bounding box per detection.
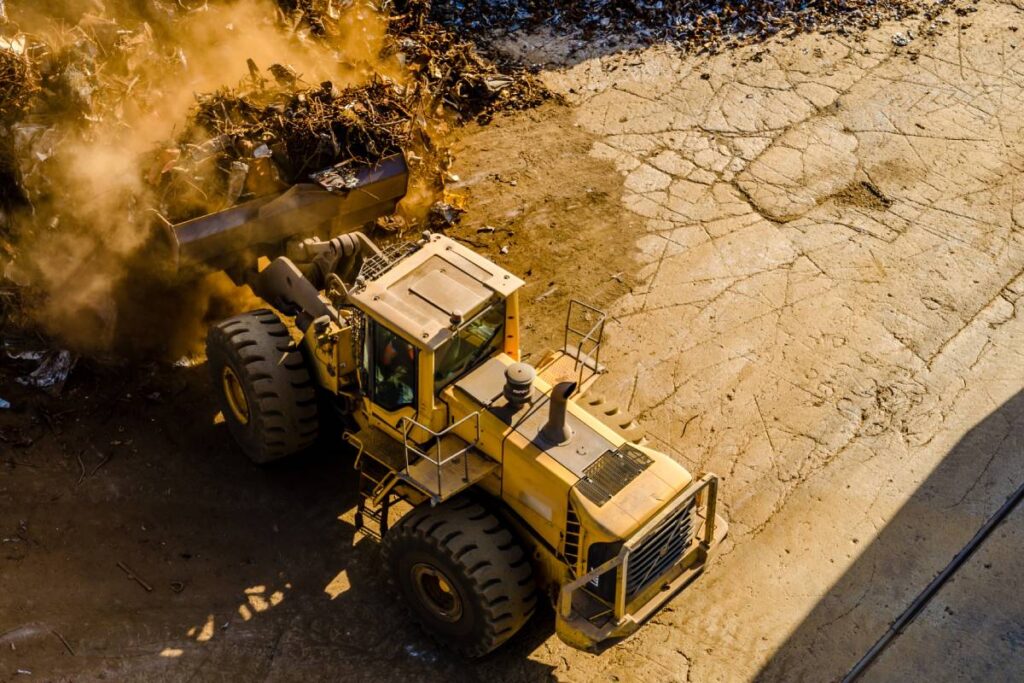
[159,76,415,223]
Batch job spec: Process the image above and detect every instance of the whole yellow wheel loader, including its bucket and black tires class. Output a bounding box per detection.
[170,157,726,656]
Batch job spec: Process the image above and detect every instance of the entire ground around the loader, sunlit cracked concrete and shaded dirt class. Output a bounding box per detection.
[0,0,1024,681]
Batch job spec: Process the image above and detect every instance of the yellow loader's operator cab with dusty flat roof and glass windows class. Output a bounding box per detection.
[348,234,523,440]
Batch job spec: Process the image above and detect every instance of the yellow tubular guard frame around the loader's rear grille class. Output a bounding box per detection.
[558,474,718,622]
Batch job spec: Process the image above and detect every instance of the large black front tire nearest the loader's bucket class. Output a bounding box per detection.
[206,308,319,464]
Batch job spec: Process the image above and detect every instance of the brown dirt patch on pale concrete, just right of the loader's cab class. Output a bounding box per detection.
[449,104,641,352]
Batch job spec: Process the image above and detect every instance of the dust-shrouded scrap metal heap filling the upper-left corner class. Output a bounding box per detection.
[0,0,550,358]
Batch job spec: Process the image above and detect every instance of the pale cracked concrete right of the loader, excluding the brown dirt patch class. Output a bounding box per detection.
[520,2,1024,681]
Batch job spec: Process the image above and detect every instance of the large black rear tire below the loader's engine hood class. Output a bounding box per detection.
[381,498,537,657]
